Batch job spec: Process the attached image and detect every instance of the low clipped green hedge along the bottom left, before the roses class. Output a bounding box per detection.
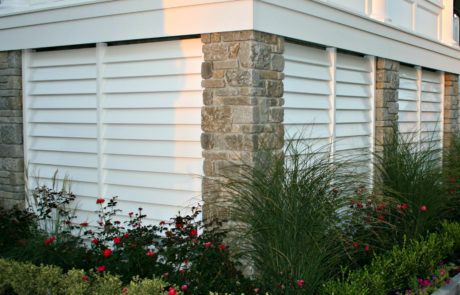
[0,259,167,295]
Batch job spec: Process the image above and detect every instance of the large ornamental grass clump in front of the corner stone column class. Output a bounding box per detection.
[227,145,356,294]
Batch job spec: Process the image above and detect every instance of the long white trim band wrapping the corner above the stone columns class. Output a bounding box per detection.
[0,0,460,73]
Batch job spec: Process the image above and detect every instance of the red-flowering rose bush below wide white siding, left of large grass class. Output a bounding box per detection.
[84,198,253,294]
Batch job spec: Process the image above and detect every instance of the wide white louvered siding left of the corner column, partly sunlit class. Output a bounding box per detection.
[25,39,202,221]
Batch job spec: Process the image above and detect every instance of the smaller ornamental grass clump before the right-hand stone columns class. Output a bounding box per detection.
[374,128,452,248]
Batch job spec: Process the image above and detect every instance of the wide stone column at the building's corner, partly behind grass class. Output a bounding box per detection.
[201,31,284,221]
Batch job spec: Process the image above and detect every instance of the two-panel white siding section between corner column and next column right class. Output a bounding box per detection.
[284,43,374,173]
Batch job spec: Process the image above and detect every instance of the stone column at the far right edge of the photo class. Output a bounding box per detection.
[443,73,459,148]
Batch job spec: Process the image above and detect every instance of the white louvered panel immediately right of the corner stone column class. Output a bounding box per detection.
[284,43,331,146]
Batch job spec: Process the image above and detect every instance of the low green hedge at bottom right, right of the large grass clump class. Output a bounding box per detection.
[322,223,460,295]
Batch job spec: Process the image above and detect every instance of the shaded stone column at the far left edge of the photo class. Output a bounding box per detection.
[0,51,25,208]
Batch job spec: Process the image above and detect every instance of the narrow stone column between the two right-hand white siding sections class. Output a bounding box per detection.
[374,57,399,152]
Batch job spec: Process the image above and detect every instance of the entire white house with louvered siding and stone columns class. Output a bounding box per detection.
[0,0,460,224]
